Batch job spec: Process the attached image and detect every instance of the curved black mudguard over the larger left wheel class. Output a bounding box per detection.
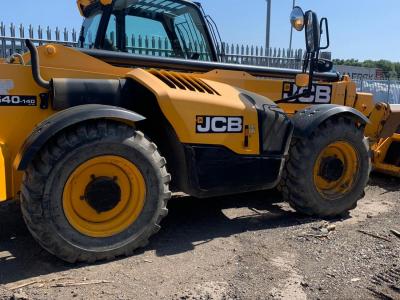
[14,104,145,171]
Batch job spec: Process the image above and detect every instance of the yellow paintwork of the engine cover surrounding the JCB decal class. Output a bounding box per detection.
[126,69,259,155]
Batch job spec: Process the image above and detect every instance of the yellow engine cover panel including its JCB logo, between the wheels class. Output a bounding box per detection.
[127,69,260,155]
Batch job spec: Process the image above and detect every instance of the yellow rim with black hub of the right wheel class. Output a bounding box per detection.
[314,141,359,200]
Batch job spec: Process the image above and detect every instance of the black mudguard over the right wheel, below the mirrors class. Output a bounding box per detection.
[292,104,370,138]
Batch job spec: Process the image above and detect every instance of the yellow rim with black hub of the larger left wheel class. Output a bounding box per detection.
[63,155,146,237]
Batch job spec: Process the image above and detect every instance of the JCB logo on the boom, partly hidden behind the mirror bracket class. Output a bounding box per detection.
[282,82,332,104]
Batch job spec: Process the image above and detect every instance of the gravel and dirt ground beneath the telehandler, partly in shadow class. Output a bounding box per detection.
[0,175,400,300]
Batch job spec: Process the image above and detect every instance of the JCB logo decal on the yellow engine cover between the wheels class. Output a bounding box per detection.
[196,116,243,133]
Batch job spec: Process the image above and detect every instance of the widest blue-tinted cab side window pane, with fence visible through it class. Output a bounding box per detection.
[125,15,175,57]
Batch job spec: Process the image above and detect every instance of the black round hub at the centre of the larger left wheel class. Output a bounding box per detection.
[84,177,121,214]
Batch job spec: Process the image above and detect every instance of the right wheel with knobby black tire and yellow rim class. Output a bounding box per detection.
[280,117,371,217]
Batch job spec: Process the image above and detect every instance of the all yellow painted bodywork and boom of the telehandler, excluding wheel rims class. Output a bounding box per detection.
[0,42,398,201]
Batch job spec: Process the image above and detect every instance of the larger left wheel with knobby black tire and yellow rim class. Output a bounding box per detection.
[21,120,171,263]
